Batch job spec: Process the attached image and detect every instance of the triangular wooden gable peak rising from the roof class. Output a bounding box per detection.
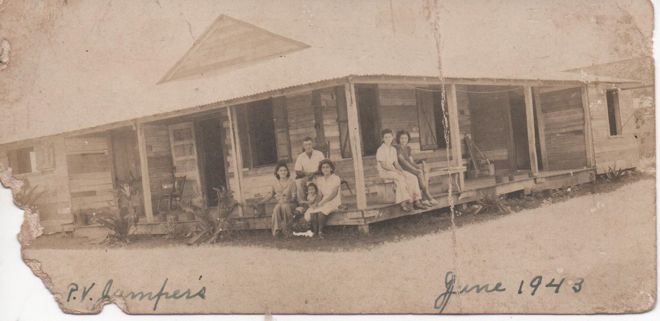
[159,15,309,83]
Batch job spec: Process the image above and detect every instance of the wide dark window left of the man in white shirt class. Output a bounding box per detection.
[236,99,278,168]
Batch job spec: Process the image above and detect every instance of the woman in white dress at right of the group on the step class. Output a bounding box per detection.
[305,159,341,238]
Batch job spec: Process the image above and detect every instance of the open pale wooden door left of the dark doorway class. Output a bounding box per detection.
[168,122,202,199]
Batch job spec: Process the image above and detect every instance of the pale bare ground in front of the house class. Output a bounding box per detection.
[24,175,656,313]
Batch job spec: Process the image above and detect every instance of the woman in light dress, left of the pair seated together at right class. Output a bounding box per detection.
[376,129,428,212]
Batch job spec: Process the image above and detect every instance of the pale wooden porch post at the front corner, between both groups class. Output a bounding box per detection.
[344,78,367,210]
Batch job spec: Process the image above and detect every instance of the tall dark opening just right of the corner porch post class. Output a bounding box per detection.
[355,86,381,156]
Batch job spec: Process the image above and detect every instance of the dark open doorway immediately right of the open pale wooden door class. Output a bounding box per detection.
[199,118,227,207]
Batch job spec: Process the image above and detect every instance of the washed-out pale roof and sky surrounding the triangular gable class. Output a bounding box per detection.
[0,0,652,143]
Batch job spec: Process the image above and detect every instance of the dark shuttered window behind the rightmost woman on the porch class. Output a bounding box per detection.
[417,89,447,150]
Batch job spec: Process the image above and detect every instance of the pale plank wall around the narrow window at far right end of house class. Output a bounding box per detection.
[587,85,639,174]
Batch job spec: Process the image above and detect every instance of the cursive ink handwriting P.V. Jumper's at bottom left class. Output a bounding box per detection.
[66,276,206,311]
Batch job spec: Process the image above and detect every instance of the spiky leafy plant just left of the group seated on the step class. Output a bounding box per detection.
[187,187,240,245]
